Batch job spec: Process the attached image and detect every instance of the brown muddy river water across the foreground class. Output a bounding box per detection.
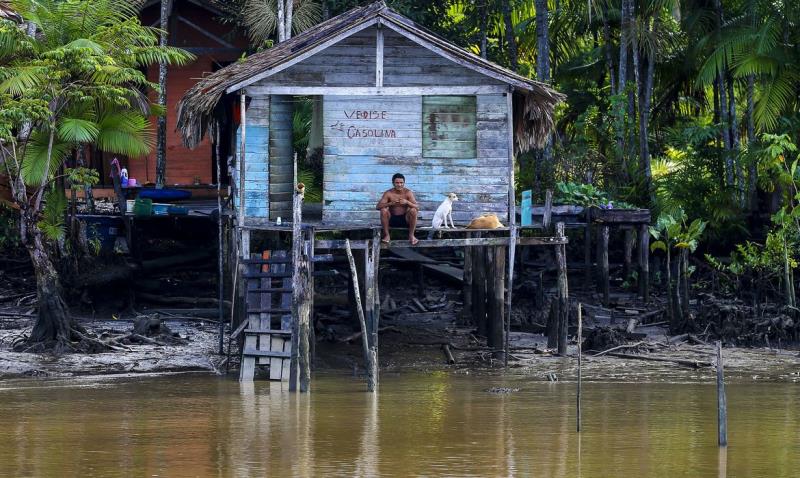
[0,372,800,477]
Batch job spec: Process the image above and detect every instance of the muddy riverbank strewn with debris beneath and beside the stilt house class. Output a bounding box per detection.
[0,243,800,380]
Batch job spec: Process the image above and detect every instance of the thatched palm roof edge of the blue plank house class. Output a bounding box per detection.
[178,1,564,151]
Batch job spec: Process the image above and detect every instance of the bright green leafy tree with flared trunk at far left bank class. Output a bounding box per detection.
[0,0,191,350]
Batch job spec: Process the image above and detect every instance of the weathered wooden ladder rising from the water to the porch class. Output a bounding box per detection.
[239,251,292,381]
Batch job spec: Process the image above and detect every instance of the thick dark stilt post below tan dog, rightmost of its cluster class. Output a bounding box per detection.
[486,246,506,363]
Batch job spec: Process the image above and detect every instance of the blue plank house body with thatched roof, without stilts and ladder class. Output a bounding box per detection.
[178,2,562,225]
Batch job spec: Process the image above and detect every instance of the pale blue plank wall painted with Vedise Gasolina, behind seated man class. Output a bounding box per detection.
[323,95,509,225]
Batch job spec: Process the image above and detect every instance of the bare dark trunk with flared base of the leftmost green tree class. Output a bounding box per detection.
[21,217,72,350]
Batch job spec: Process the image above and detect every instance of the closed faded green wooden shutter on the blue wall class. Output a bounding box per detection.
[422,96,477,159]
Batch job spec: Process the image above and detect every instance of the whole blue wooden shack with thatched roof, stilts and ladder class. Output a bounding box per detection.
[178,2,568,391]
